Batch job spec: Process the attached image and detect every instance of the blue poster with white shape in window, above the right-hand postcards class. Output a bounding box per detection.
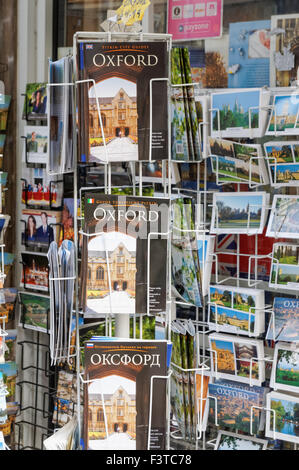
[228,20,271,88]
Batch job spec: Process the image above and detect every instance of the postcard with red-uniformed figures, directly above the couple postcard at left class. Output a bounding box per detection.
[22,167,63,209]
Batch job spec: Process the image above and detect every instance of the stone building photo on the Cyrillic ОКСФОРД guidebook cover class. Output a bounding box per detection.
[88,375,136,450]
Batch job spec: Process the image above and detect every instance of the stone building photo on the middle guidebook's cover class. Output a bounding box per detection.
[87,232,136,313]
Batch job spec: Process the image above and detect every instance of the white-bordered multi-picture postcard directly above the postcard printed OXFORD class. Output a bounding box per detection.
[209,333,265,385]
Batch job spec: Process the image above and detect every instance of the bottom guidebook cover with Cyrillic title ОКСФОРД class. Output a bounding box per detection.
[84,340,167,450]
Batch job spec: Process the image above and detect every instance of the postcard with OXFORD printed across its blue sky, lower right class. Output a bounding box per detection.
[209,380,265,434]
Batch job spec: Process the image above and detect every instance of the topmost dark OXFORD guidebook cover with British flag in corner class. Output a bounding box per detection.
[79,42,168,162]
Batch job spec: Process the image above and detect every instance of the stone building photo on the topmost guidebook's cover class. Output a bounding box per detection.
[89,77,138,161]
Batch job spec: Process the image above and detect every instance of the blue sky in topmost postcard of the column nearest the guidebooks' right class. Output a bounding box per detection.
[212,91,260,113]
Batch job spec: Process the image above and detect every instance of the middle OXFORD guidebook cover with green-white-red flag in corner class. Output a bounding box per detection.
[82,192,169,318]
